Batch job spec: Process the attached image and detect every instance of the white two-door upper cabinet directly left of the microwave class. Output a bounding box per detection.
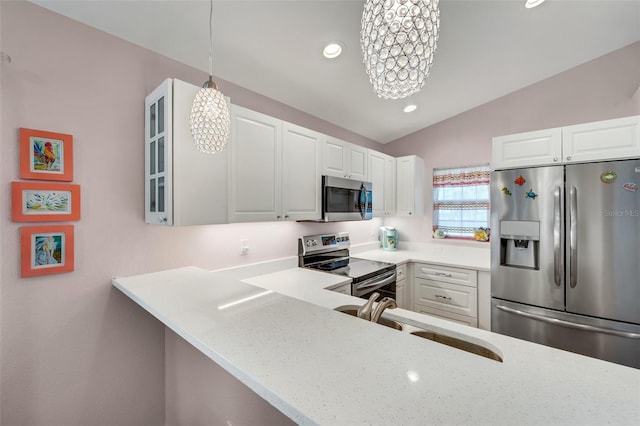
[229,105,322,222]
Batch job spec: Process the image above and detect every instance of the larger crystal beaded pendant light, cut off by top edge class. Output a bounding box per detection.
[360,0,440,99]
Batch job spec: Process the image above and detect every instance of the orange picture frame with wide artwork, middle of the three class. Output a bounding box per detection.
[11,182,80,222]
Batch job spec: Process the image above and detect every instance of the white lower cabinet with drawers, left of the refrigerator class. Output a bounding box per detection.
[413,262,478,327]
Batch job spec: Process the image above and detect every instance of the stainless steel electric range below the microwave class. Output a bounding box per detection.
[298,232,396,299]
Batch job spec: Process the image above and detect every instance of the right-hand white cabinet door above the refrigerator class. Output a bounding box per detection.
[562,116,640,163]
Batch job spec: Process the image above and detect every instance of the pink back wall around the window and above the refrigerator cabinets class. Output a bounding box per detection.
[384,42,640,241]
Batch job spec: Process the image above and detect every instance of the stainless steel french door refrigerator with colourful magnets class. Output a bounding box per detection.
[491,159,640,368]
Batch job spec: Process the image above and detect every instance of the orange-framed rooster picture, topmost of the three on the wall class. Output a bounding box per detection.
[20,128,73,182]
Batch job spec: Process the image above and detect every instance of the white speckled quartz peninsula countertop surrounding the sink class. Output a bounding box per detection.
[113,258,640,425]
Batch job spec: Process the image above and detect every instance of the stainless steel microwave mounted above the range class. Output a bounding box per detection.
[322,176,373,222]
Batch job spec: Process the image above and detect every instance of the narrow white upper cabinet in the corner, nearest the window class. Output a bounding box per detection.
[396,155,424,216]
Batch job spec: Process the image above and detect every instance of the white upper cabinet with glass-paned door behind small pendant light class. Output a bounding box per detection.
[145,79,228,226]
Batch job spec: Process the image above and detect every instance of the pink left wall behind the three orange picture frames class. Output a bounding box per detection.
[0,1,380,426]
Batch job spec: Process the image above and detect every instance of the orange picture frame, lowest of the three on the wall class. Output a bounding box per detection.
[20,225,75,277]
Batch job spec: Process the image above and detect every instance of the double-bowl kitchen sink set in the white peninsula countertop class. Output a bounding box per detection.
[334,305,502,362]
